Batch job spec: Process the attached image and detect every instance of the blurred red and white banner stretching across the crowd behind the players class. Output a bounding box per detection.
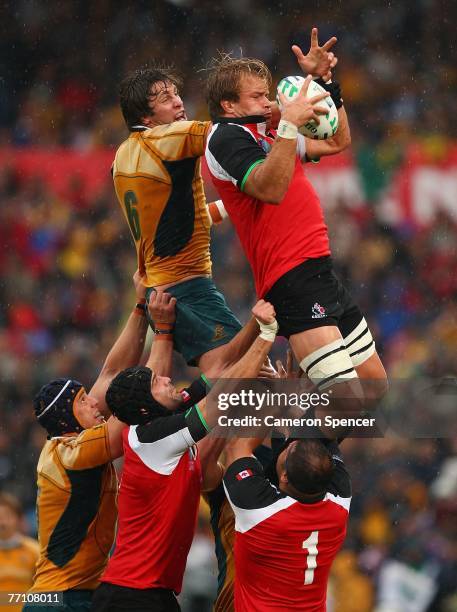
[0,145,457,227]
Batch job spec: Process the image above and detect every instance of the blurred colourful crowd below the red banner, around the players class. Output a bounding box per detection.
[0,160,457,612]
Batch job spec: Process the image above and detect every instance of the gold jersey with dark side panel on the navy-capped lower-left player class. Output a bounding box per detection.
[31,423,117,592]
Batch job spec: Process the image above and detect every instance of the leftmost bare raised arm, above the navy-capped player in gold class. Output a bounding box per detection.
[89,270,148,412]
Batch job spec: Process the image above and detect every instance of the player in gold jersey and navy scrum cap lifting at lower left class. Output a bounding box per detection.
[24,272,148,612]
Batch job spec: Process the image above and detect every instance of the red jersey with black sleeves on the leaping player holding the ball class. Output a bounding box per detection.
[206,117,330,298]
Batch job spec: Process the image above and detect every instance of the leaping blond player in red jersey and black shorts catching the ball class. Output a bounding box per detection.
[206,29,387,430]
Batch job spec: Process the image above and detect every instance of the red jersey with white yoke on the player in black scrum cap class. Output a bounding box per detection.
[101,407,207,593]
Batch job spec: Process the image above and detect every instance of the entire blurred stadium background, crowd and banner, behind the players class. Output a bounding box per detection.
[0,0,457,612]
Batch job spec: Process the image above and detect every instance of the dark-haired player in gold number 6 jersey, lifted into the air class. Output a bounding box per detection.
[113,68,249,376]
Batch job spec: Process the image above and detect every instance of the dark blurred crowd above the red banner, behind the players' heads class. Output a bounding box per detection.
[0,0,457,150]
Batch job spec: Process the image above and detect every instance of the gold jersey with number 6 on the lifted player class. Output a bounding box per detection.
[113,121,211,287]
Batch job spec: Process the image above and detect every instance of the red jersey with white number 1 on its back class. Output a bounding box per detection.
[224,444,351,612]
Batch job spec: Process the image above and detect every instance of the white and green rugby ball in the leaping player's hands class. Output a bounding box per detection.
[276,76,338,140]
